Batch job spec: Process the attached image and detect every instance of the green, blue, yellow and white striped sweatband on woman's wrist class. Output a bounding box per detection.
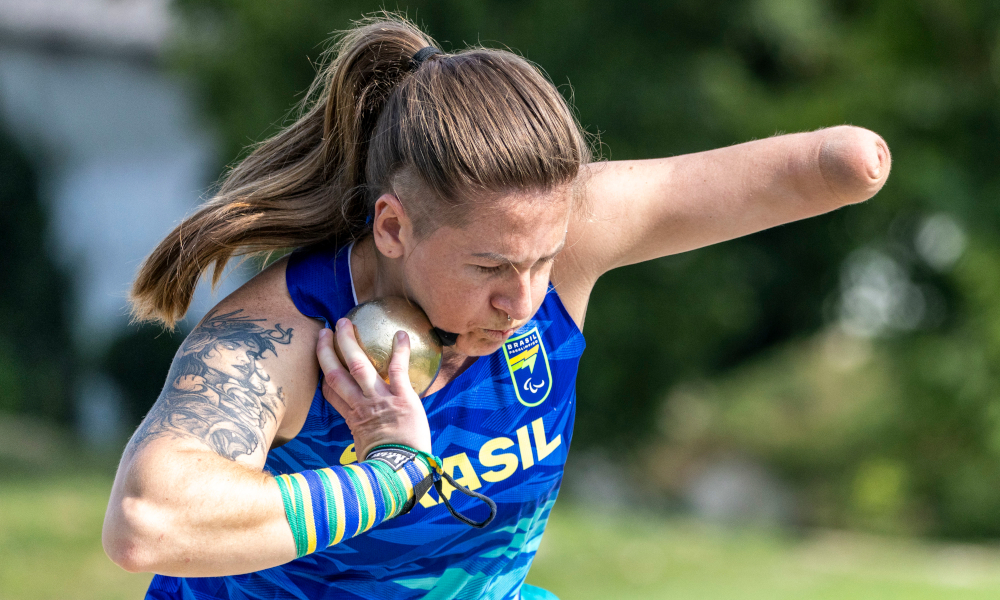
[275,444,441,557]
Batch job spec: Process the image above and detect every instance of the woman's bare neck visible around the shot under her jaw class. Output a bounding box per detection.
[351,236,475,372]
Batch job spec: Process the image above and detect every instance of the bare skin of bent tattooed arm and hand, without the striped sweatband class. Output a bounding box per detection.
[103,263,430,577]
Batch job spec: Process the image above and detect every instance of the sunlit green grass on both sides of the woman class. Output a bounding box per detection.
[0,475,1000,600]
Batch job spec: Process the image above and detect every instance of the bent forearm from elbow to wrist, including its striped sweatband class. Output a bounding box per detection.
[104,451,431,577]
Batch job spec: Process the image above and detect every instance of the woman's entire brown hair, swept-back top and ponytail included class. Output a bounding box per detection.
[130,13,590,327]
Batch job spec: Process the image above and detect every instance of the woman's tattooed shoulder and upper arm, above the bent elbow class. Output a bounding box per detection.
[126,255,321,467]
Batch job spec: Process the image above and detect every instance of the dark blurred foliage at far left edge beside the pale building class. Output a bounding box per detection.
[0,128,73,422]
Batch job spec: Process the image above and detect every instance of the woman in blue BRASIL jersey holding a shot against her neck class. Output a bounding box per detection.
[104,18,889,598]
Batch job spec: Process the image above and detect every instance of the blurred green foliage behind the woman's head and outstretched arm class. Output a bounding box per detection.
[173,0,1000,536]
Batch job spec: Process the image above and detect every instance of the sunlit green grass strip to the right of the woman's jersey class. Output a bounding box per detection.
[528,506,1000,600]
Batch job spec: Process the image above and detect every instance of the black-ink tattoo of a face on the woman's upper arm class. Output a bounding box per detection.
[129,309,292,460]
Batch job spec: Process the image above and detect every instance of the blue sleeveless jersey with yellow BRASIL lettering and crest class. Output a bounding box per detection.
[147,246,584,600]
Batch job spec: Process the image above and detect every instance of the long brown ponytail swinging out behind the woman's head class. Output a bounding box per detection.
[130,15,433,328]
